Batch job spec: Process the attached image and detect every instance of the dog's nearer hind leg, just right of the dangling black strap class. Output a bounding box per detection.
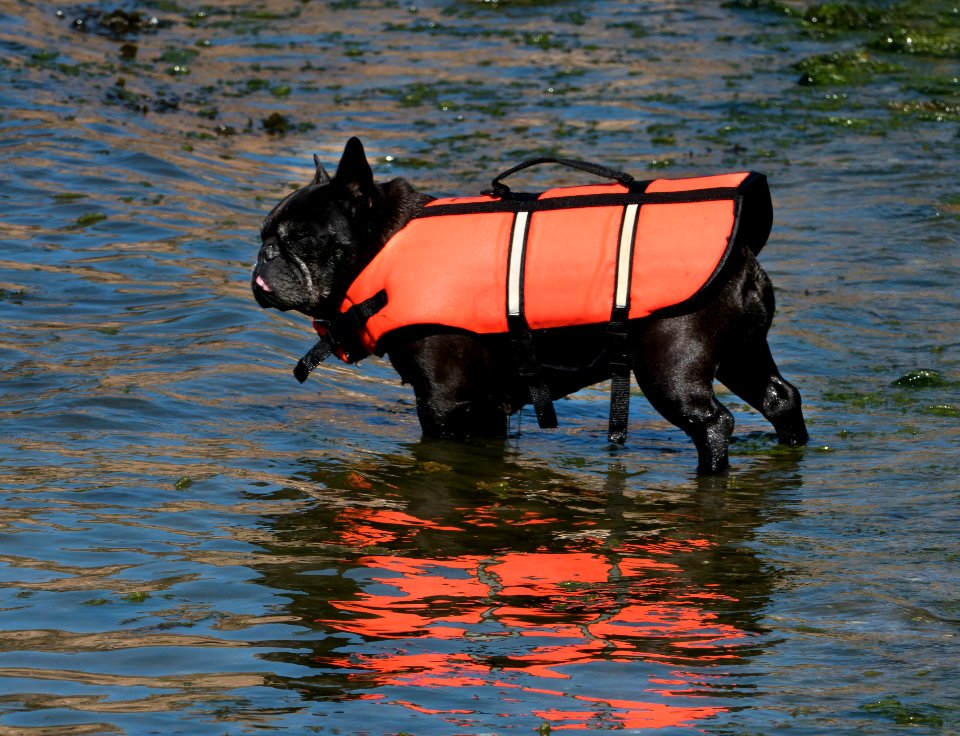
[633,322,733,473]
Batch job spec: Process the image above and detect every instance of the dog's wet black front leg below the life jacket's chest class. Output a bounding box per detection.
[390,333,507,440]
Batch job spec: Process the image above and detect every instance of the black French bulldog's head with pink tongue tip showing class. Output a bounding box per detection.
[251,138,389,319]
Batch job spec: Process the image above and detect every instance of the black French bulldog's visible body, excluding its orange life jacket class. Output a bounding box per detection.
[252,138,807,473]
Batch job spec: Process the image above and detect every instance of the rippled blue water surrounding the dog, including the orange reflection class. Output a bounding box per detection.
[0,0,960,736]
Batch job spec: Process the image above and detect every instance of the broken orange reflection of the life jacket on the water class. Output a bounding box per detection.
[319,509,751,730]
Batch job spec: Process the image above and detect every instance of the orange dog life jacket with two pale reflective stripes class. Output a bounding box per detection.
[341,173,769,354]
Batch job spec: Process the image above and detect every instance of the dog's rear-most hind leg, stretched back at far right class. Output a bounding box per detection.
[717,339,808,445]
